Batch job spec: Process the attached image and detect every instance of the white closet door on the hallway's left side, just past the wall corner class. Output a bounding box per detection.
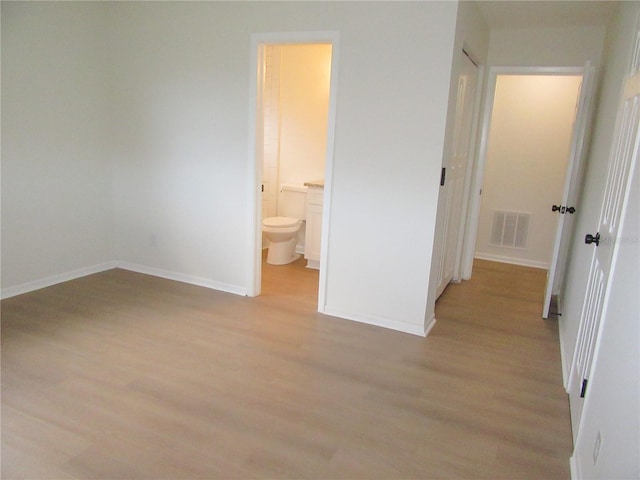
[436,51,478,298]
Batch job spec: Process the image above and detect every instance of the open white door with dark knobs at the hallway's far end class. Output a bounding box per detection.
[542,62,595,318]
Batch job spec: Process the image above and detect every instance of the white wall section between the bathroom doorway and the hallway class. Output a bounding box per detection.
[325,2,456,333]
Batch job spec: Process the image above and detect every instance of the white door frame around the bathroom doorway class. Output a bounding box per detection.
[245,31,340,312]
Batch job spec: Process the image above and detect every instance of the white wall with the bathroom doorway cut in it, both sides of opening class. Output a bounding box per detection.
[111,2,456,333]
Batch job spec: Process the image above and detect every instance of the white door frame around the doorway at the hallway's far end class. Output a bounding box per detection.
[462,66,584,280]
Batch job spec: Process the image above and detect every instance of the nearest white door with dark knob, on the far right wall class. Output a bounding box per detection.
[568,38,640,441]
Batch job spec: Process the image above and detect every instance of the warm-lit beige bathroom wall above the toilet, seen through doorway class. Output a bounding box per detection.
[262,44,331,218]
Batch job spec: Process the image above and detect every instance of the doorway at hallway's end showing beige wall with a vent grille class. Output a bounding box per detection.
[463,63,593,314]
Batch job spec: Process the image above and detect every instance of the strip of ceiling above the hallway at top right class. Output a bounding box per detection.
[477,0,617,28]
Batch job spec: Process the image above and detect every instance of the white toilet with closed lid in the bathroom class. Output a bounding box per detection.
[262,185,307,265]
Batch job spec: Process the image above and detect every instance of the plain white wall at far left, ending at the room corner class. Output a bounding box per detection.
[2,2,114,296]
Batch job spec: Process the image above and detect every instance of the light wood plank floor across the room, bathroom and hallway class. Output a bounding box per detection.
[2,262,571,479]
